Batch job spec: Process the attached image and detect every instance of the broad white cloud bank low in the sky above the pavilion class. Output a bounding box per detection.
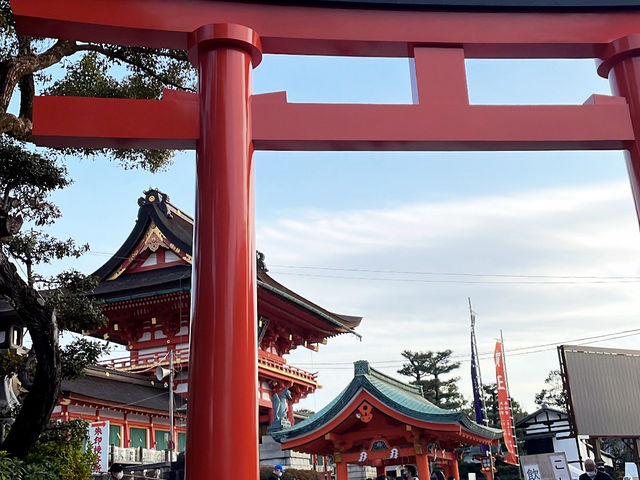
[258,183,640,409]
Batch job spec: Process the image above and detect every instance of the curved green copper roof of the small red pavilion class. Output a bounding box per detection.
[271,360,502,443]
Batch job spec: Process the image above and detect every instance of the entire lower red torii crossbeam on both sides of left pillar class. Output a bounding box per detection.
[33,93,634,150]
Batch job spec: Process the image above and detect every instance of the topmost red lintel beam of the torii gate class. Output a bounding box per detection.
[11,0,640,58]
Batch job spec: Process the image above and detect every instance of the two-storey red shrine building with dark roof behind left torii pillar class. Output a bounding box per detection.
[54,189,362,461]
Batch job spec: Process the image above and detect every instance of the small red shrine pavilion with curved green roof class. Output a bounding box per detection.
[273,360,502,480]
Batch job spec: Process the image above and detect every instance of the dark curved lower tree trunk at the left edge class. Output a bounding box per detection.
[0,250,61,458]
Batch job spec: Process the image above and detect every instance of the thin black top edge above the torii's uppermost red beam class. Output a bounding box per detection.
[239,0,640,12]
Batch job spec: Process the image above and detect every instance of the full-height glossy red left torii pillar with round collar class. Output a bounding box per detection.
[185,24,262,480]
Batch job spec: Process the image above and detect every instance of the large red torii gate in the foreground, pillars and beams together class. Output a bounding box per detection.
[11,0,640,480]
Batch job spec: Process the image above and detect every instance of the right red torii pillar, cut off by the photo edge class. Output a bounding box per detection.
[598,34,640,220]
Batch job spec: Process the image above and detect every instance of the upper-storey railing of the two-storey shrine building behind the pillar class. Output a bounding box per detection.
[99,348,318,383]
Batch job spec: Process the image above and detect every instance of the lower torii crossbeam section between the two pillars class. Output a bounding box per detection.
[253,96,634,150]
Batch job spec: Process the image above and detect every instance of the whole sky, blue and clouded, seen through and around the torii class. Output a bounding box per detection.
[31,55,640,410]
